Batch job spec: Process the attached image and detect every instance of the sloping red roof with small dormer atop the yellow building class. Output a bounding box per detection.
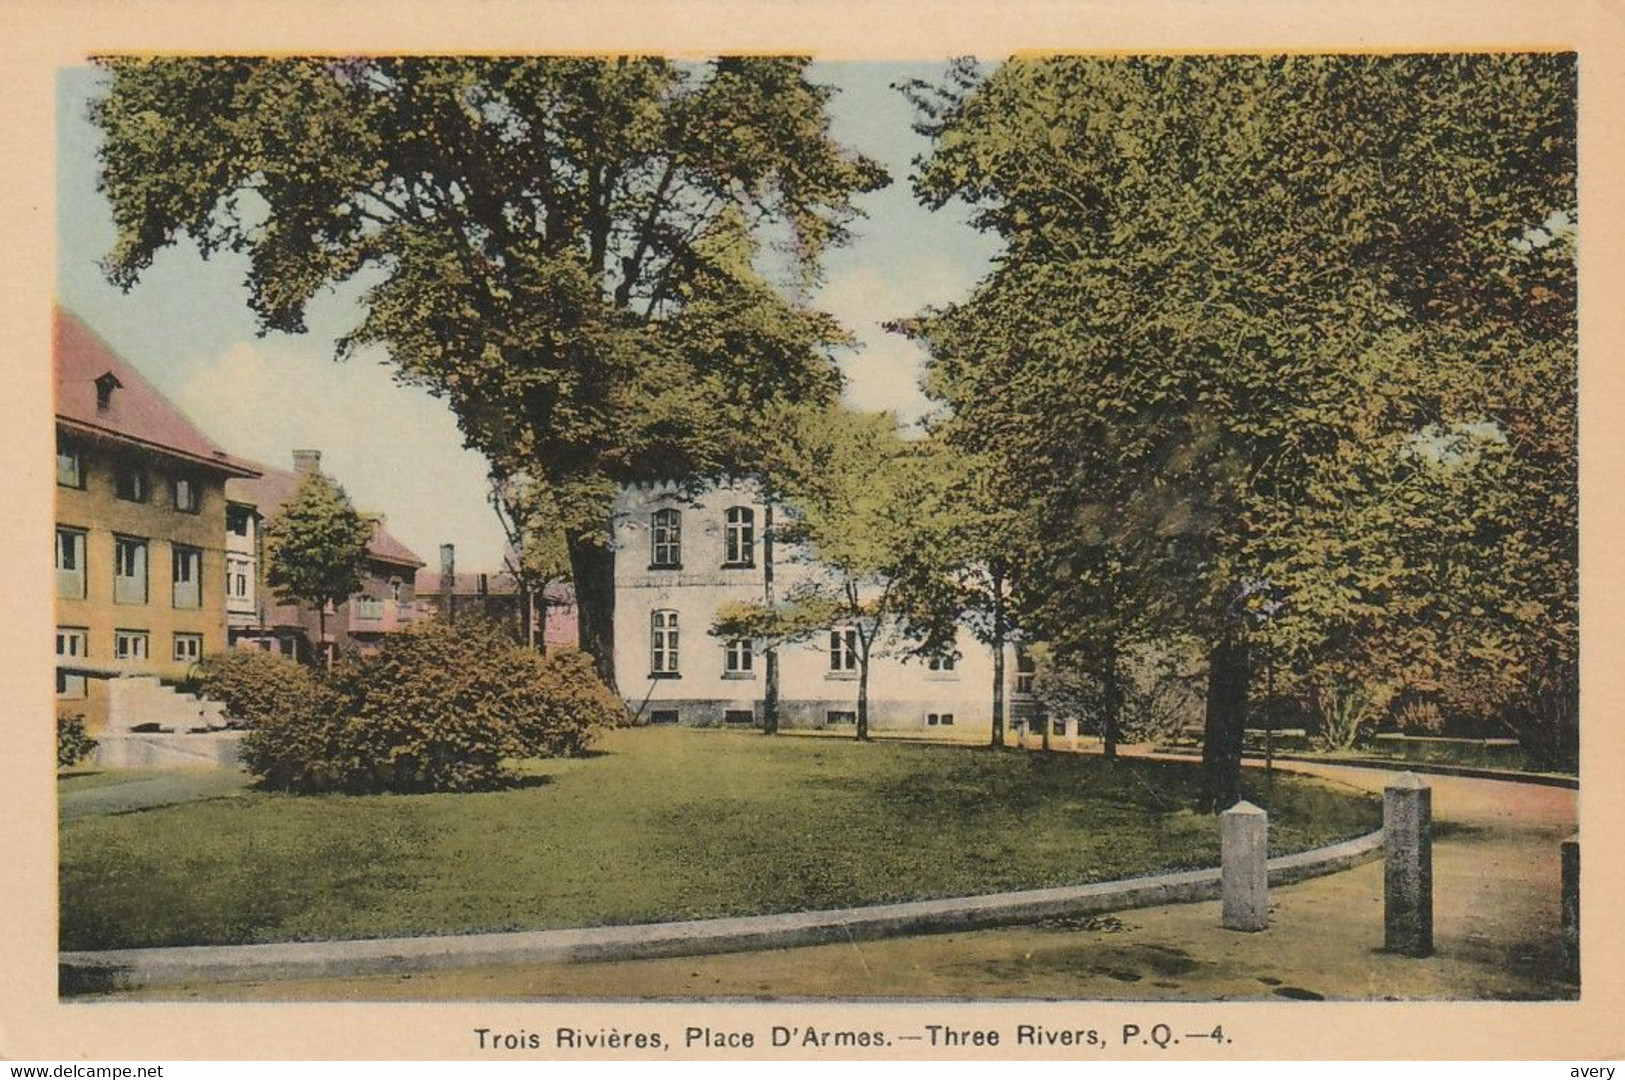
[50,309,257,477]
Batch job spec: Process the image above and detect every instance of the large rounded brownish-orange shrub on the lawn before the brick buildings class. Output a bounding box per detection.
[244,620,624,794]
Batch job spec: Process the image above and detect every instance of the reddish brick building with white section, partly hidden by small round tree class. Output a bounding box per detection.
[226,450,424,659]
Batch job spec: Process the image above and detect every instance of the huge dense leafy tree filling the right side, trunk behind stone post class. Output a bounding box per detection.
[910,55,1576,807]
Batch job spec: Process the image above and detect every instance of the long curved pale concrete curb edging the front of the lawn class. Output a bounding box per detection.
[59,830,1383,996]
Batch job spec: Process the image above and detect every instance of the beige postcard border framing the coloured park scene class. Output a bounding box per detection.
[0,0,1625,1061]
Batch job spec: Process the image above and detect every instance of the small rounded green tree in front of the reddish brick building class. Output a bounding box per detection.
[265,471,372,609]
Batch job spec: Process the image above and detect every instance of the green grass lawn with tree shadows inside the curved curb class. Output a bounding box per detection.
[60,729,1381,948]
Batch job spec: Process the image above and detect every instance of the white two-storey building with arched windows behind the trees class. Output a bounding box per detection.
[614,481,1030,741]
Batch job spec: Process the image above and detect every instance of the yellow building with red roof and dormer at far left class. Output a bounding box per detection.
[52,310,258,729]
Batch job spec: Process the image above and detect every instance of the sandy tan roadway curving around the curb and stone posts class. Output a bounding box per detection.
[101,765,1576,1000]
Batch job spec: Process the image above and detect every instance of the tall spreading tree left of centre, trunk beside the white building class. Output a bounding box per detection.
[91,57,886,676]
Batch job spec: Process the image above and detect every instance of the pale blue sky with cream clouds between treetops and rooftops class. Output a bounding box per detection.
[57,62,996,568]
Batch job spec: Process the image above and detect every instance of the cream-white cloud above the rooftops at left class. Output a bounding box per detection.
[176,339,504,568]
